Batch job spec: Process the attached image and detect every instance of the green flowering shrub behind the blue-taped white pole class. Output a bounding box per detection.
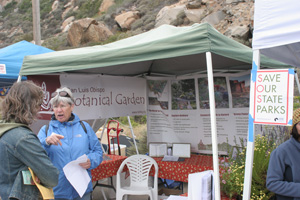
[220,135,277,200]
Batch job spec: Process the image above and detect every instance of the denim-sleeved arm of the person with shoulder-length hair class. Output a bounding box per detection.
[15,129,59,188]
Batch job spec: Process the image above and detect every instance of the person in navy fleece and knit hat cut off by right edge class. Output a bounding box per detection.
[266,108,300,200]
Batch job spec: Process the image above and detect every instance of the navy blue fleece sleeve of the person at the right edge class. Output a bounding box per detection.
[266,148,300,197]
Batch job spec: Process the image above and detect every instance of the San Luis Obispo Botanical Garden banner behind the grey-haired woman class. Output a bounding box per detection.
[28,74,146,120]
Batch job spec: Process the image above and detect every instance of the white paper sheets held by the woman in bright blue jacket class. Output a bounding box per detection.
[63,154,91,198]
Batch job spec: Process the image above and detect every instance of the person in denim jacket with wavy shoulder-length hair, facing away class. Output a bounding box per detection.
[0,81,59,200]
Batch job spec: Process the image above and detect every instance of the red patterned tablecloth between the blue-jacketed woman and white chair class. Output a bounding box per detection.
[92,155,127,181]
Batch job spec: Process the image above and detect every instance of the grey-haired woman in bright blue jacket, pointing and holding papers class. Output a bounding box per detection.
[38,87,103,200]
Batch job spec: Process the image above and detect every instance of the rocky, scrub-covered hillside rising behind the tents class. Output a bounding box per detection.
[0,0,254,50]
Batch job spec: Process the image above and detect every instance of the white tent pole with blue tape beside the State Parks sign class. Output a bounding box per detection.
[243,50,260,200]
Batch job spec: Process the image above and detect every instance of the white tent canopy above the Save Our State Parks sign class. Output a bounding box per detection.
[252,0,300,67]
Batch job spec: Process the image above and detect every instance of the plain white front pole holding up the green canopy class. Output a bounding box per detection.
[206,52,221,200]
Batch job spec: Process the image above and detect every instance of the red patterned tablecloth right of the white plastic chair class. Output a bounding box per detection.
[154,155,213,182]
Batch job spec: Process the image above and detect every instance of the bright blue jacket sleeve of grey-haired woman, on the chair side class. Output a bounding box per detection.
[83,122,103,169]
